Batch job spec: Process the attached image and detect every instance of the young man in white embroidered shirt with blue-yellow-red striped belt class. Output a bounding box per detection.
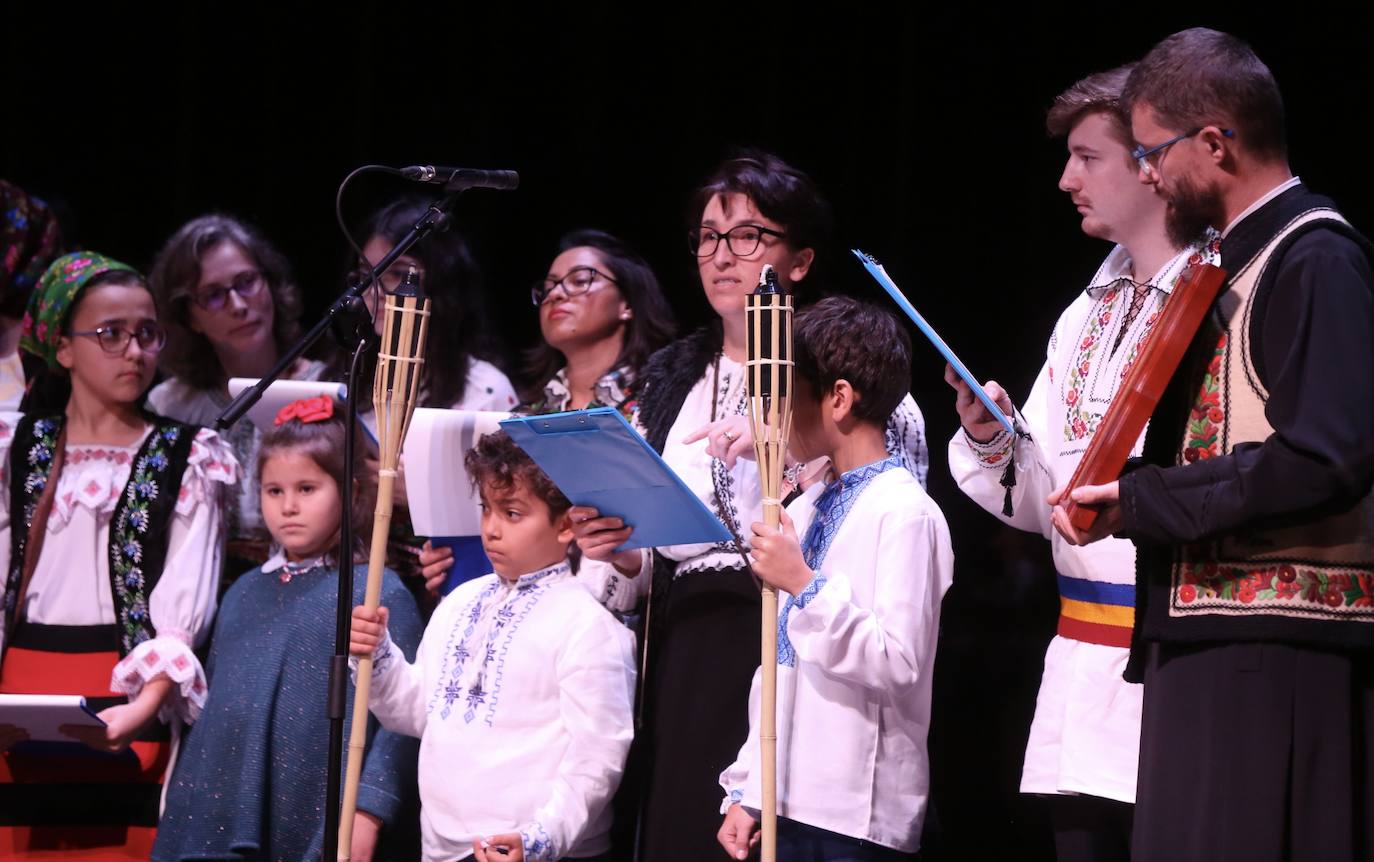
[945,66,1216,862]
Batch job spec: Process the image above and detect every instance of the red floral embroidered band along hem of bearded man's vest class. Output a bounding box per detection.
[1172,561,1374,620]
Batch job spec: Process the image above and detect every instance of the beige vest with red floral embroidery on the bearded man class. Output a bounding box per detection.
[1168,208,1374,623]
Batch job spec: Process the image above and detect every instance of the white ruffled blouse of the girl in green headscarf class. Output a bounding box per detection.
[0,414,239,722]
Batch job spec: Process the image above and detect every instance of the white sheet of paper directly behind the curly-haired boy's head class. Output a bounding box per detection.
[401,407,511,536]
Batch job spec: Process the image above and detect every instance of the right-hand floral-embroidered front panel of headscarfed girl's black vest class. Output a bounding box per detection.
[110,425,181,653]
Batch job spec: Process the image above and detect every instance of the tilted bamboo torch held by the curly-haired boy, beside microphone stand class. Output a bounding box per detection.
[338,267,430,862]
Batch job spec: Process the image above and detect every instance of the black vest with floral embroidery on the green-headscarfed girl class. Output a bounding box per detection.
[4,415,196,657]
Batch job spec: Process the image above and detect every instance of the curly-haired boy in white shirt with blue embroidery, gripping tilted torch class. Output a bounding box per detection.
[350,433,635,862]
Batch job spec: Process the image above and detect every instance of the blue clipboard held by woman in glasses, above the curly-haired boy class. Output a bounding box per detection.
[502,407,730,550]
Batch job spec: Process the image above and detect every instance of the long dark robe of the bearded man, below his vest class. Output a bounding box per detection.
[1134,643,1374,862]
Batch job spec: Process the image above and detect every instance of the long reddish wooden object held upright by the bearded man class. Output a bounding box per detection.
[1065,264,1226,531]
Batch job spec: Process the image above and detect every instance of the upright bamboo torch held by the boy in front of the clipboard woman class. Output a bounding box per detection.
[745,265,793,862]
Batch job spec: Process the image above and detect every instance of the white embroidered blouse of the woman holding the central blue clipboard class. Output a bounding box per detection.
[578,353,929,610]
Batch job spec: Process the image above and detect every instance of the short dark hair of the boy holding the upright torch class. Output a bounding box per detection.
[793,297,911,426]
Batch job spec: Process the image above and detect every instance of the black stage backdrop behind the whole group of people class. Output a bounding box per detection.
[8,3,1374,859]
